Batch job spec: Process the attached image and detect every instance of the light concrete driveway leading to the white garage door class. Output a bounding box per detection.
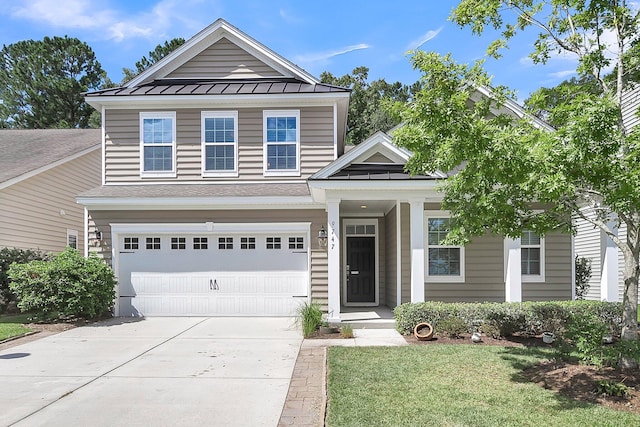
[0,317,302,426]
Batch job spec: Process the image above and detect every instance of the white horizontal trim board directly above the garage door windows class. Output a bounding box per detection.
[110,222,311,234]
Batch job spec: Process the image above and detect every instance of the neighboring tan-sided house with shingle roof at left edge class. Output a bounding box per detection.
[0,129,101,252]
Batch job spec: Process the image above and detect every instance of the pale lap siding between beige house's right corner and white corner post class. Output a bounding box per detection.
[574,219,602,301]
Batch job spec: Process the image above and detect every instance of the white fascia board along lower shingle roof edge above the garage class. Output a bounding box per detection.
[76,196,324,210]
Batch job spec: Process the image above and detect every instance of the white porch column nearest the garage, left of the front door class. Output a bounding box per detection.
[327,199,340,322]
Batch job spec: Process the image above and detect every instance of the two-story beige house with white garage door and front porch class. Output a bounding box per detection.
[78,20,573,320]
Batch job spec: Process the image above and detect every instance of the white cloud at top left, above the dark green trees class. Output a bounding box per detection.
[10,0,210,41]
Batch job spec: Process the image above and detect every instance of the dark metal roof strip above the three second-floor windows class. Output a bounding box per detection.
[86,78,350,97]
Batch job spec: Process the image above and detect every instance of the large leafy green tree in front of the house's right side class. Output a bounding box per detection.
[394,0,640,368]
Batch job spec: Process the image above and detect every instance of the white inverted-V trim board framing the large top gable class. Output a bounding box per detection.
[126,19,320,87]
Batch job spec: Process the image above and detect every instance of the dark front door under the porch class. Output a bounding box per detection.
[347,237,376,303]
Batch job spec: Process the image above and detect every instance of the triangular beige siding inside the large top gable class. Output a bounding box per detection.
[167,38,282,79]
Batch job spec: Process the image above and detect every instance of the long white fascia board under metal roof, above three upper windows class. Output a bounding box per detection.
[85,92,349,109]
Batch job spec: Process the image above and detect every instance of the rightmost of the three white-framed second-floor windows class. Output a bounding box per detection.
[263,110,300,176]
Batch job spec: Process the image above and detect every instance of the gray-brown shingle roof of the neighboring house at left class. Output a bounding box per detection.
[0,129,102,183]
